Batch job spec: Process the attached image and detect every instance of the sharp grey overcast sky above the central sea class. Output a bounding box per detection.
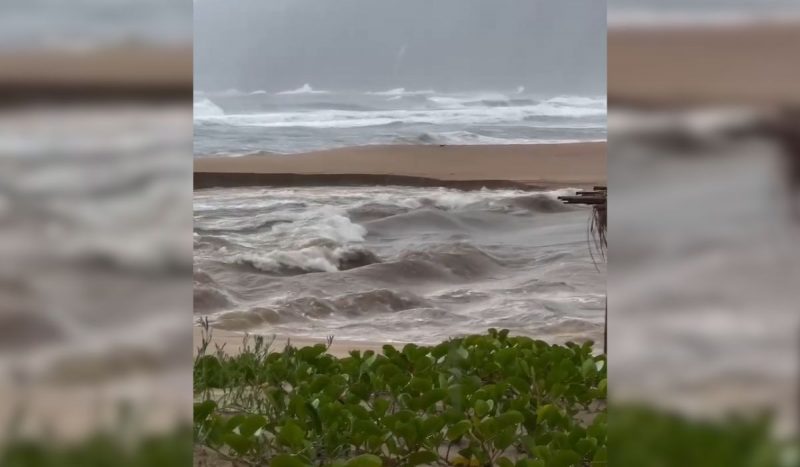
[194,0,606,95]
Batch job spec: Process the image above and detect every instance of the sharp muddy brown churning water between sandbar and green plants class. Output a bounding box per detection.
[194,187,605,342]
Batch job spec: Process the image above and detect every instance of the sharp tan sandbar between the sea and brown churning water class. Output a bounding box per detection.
[194,143,606,189]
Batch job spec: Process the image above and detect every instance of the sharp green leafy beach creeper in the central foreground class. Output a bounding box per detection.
[194,329,607,467]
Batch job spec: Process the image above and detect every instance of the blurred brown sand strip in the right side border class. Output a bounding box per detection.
[608,23,800,107]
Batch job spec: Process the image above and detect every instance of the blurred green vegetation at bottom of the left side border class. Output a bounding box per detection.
[0,426,192,467]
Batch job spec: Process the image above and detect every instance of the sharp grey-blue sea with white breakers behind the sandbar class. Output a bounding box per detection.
[194,89,606,156]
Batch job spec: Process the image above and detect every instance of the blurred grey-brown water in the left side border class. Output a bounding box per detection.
[0,104,191,376]
